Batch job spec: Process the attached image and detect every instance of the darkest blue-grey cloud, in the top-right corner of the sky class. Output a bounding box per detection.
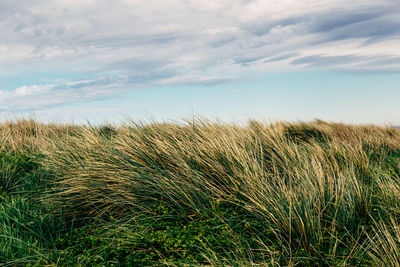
[244,1,400,44]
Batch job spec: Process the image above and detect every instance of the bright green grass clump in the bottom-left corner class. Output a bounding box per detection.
[0,197,61,265]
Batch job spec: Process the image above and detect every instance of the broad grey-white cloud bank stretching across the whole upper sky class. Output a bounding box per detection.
[0,0,400,110]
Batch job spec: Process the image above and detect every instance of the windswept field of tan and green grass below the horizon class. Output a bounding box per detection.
[0,120,400,266]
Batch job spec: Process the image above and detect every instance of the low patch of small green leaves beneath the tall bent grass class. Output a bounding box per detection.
[53,204,271,266]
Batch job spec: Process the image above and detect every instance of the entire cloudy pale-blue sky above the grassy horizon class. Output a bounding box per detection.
[0,0,400,125]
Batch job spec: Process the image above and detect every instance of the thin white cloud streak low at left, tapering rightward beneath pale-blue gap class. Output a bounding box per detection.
[0,73,240,112]
